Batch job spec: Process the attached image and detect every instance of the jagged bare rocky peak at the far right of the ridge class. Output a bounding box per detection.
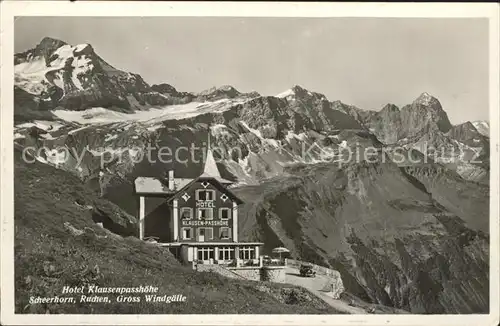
[336,93,489,183]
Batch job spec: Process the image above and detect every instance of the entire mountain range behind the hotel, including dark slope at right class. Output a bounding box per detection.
[14,38,489,313]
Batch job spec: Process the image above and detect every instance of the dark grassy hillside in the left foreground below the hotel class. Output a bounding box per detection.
[15,153,337,314]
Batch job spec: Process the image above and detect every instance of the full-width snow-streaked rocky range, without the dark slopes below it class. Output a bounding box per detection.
[14,38,488,184]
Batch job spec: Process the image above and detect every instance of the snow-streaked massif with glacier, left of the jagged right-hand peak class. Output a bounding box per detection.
[15,38,372,183]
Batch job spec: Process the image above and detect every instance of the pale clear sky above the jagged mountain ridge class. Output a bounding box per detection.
[15,17,488,123]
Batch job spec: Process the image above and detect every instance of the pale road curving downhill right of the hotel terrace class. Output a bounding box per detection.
[286,267,367,314]
